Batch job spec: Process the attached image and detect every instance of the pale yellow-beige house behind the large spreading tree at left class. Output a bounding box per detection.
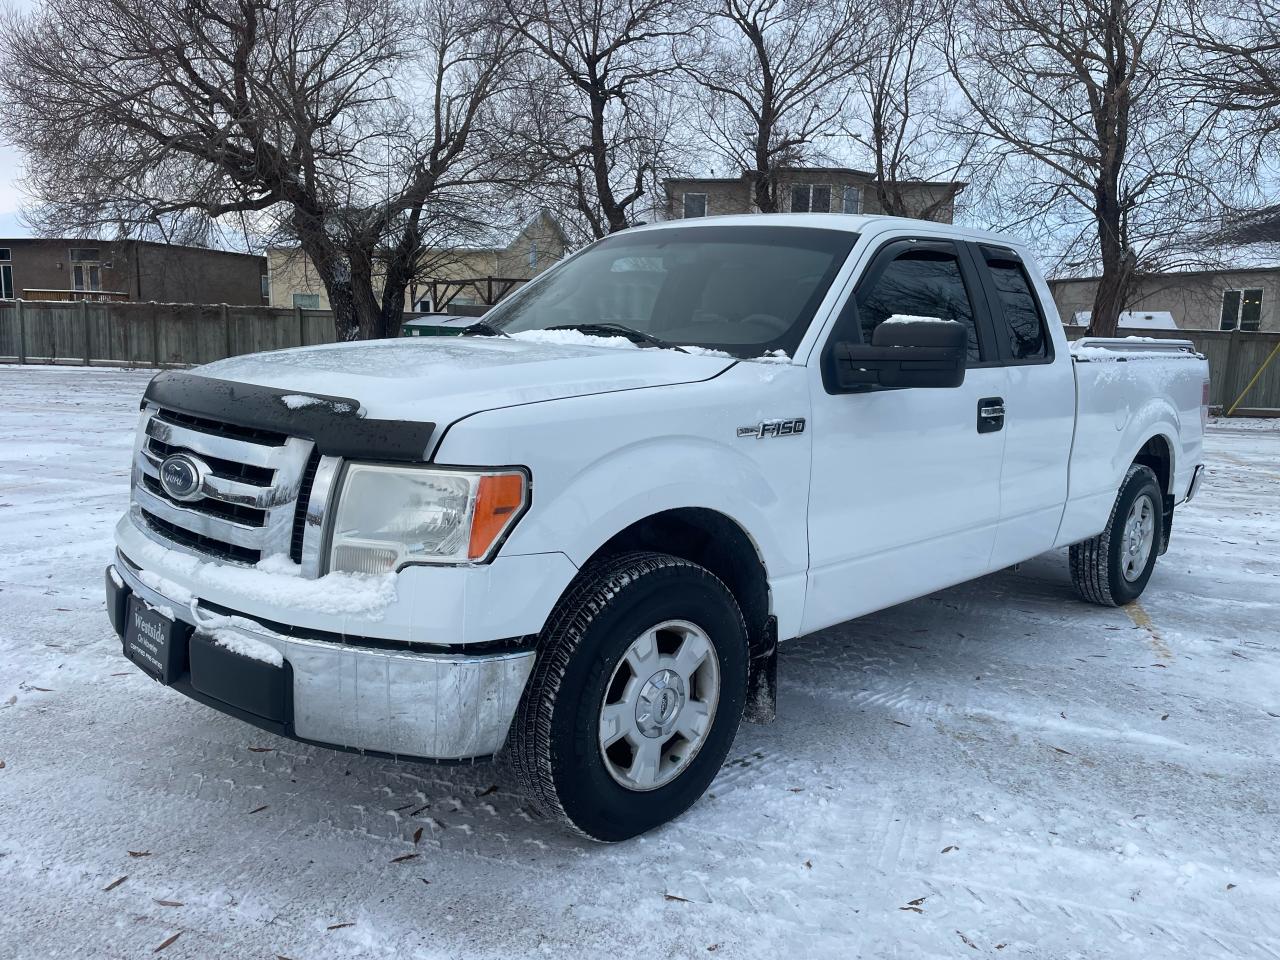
[266,210,568,312]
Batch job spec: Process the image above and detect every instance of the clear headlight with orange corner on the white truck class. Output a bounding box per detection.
[329,463,529,573]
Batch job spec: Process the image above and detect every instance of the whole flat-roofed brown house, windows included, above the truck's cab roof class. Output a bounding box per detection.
[663,166,965,223]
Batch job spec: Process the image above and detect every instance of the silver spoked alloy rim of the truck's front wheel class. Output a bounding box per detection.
[599,620,719,791]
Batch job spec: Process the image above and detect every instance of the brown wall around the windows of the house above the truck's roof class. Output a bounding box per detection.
[667,168,955,223]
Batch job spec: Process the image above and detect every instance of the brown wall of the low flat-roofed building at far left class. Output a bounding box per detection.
[0,238,266,306]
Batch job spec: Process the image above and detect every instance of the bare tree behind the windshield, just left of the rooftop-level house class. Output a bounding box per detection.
[503,0,690,238]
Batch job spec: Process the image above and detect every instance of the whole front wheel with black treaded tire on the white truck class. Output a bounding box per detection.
[509,553,749,842]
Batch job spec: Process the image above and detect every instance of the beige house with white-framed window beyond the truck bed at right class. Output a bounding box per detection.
[1050,268,1280,330]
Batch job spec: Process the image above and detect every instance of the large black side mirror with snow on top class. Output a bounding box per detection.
[835,316,969,393]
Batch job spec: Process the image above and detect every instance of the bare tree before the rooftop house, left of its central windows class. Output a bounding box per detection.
[686,0,868,212]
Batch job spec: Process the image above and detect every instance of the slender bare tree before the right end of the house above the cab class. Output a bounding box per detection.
[844,0,975,220]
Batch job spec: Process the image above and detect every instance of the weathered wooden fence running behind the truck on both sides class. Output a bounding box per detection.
[0,301,1280,412]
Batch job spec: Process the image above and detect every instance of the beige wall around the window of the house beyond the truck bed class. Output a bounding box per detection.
[1050,268,1280,330]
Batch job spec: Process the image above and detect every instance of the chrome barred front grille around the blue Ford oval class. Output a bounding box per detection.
[132,406,320,563]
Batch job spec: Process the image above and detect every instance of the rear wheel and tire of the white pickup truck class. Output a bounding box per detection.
[1071,463,1165,607]
